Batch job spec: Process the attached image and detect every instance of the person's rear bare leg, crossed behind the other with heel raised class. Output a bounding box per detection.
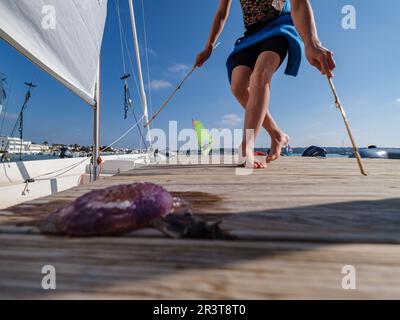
[231,59,289,162]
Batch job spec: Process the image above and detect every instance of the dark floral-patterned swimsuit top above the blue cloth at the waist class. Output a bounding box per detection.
[240,0,287,32]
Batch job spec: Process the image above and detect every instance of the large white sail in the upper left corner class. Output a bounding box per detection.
[0,0,107,105]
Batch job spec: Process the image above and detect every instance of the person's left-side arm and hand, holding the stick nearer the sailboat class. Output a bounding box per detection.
[194,0,232,67]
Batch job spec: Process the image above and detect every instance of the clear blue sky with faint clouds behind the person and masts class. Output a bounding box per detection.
[0,0,400,147]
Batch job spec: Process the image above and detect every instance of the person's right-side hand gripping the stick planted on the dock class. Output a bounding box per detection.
[306,41,336,78]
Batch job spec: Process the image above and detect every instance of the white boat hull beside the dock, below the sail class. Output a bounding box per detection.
[0,154,157,209]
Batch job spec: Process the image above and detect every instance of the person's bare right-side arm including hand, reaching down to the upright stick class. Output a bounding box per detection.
[292,0,336,78]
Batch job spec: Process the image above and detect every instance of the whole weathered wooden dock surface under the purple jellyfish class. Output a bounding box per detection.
[0,158,400,299]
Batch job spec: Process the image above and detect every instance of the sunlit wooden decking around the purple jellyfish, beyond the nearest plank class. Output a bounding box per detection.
[0,158,400,243]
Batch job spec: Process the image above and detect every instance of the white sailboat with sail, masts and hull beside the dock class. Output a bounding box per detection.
[0,0,158,208]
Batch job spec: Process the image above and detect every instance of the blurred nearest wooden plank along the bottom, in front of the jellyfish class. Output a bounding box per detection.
[0,235,400,299]
